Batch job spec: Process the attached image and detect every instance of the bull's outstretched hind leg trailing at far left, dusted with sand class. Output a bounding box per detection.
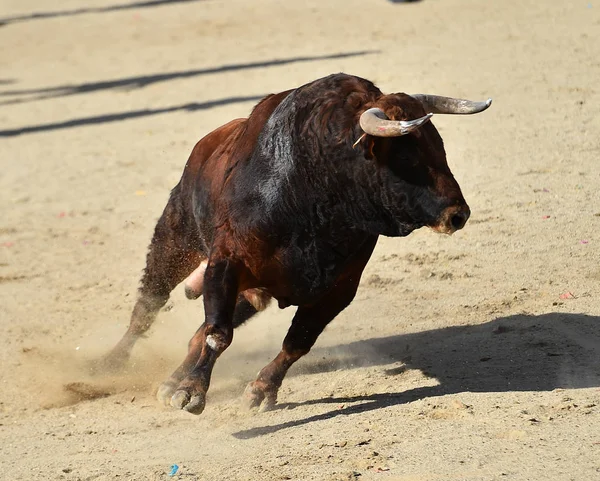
[100,201,204,370]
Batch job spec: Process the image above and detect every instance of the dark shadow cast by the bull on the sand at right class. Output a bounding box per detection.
[234,313,600,439]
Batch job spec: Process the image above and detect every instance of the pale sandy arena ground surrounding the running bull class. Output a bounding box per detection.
[0,0,600,481]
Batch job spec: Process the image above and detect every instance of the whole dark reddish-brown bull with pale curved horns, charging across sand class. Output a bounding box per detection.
[104,74,491,414]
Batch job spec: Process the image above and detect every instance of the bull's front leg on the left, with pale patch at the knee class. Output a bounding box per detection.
[164,258,239,414]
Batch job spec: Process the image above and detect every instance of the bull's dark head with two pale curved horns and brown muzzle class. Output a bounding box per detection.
[360,94,492,235]
